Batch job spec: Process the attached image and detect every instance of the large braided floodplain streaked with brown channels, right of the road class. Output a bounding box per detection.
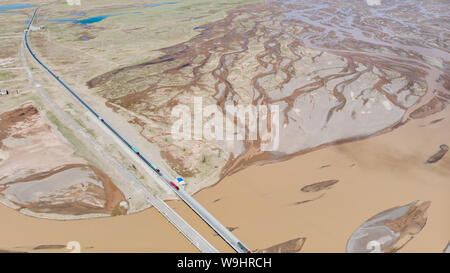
[82,1,449,191]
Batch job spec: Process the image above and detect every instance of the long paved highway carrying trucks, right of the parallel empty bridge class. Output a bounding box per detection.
[24,8,251,253]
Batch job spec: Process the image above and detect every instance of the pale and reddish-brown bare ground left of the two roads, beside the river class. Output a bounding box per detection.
[0,104,126,215]
